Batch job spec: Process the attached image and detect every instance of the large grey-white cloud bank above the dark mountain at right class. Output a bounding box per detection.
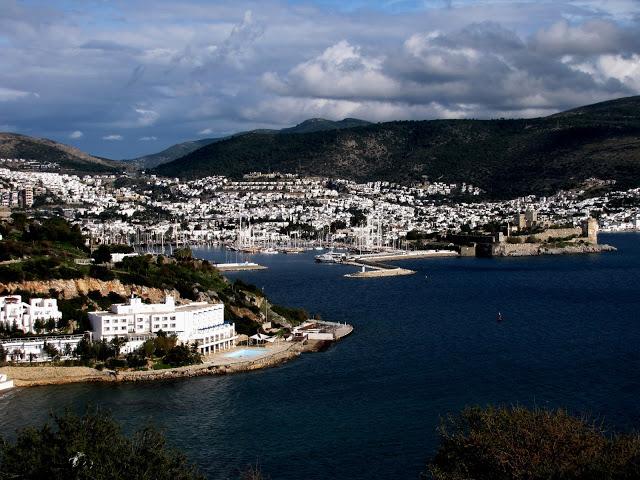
[264,22,640,120]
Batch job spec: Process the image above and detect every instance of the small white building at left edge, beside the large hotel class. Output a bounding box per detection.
[0,295,62,333]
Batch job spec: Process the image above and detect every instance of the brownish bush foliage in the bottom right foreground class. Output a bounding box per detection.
[425,407,640,480]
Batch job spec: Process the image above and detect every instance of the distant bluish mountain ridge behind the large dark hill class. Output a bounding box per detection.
[130,118,370,168]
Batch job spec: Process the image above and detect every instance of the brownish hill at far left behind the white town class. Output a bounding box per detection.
[0,133,123,173]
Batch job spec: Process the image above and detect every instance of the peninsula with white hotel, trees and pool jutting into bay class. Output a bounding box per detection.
[0,215,352,386]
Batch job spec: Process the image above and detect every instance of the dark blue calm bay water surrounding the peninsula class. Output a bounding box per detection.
[0,234,640,480]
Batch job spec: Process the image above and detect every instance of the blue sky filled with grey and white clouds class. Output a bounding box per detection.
[0,0,640,159]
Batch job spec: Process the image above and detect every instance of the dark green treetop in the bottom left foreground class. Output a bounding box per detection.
[0,410,204,480]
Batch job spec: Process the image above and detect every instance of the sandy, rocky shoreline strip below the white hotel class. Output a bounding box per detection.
[0,325,353,387]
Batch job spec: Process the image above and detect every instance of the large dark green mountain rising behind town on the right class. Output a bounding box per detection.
[156,96,640,198]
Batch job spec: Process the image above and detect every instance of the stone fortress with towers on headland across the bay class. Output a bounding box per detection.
[447,215,615,257]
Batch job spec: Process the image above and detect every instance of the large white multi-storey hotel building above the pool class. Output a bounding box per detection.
[89,296,236,355]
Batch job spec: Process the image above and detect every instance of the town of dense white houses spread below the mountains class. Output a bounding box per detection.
[0,168,640,251]
